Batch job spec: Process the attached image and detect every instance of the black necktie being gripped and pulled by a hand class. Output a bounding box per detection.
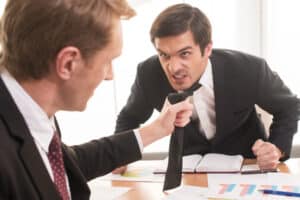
[163,81,201,190]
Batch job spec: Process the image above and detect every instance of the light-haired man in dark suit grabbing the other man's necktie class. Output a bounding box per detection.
[0,0,192,200]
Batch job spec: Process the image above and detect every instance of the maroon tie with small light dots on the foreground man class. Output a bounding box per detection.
[48,132,70,200]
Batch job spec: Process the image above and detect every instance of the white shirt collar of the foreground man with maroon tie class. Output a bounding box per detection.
[1,70,55,152]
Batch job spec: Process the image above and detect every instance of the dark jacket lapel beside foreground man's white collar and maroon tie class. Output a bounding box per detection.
[0,78,59,200]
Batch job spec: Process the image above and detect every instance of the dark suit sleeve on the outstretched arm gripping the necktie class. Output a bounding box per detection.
[67,131,141,180]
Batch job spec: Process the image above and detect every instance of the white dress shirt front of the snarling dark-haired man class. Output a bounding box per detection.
[193,60,216,139]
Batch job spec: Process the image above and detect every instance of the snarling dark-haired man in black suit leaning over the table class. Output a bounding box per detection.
[116,4,300,173]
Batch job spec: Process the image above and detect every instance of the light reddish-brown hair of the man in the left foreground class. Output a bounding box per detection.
[0,0,135,80]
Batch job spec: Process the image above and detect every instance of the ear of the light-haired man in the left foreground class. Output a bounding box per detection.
[55,46,82,80]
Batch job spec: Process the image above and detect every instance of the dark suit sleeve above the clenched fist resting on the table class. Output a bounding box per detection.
[257,61,300,160]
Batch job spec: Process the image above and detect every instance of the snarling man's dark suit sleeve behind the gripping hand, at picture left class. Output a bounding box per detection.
[115,64,154,133]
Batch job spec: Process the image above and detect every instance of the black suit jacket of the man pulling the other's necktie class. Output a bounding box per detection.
[0,78,141,200]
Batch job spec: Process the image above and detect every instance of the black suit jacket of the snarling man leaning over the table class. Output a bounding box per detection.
[116,49,300,159]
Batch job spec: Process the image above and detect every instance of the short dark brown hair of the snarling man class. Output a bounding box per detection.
[150,3,211,54]
